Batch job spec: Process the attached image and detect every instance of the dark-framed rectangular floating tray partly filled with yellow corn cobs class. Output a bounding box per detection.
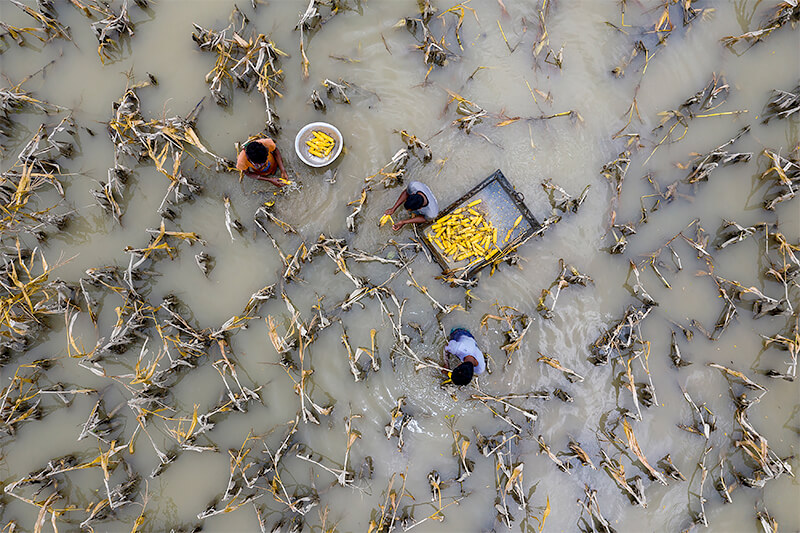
[421,170,541,280]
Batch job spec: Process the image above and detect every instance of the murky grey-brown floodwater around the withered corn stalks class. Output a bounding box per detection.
[0,0,800,531]
